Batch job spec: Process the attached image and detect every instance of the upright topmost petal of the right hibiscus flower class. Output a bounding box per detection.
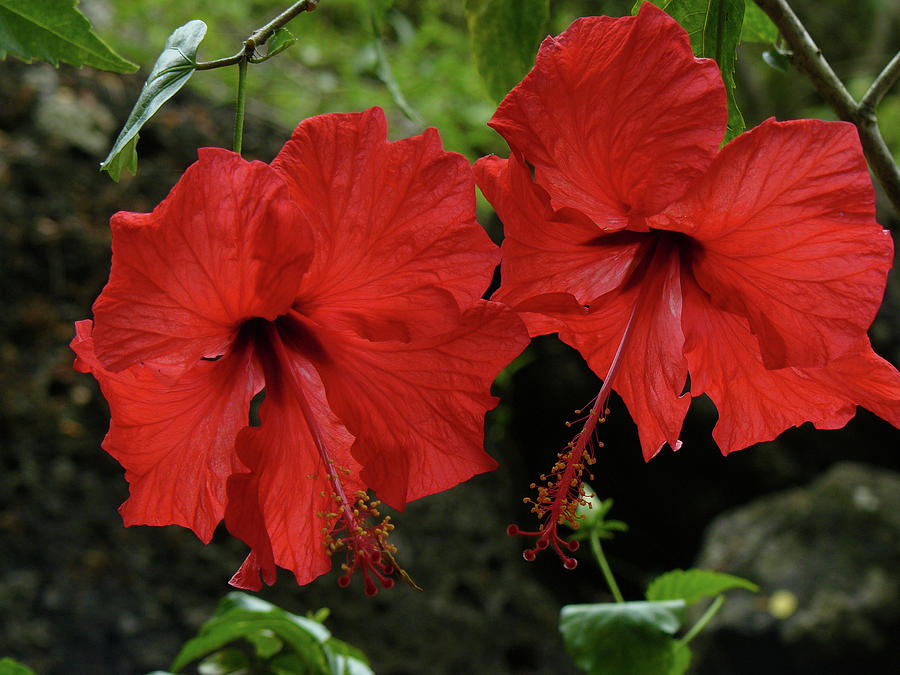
[490,3,727,229]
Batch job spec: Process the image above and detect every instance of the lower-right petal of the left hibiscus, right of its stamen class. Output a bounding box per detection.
[317,301,528,509]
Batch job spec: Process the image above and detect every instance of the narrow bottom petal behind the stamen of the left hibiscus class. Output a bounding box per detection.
[225,345,365,590]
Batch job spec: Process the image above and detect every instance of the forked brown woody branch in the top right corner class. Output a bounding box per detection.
[756,0,900,215]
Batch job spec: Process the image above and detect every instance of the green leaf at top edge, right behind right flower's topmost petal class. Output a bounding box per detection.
[631,0,744,143]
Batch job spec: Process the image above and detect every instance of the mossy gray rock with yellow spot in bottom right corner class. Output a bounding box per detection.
[694,463,900,675]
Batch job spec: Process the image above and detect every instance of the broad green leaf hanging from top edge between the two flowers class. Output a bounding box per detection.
[466,0,550,101]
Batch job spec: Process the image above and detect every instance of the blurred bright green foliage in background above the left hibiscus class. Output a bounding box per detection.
[92,0,504,158]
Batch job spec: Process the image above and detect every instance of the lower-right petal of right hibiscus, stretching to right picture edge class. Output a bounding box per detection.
[683,278,900,454]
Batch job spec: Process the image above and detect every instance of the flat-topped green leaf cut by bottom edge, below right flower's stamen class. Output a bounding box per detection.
[559,600,686,675]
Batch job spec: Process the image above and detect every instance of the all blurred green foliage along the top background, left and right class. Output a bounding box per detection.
[91,0,900,177]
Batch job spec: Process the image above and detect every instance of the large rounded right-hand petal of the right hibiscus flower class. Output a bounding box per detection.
[654,120,893,368]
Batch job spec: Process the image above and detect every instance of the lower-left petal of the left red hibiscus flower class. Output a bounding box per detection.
[71,321,262,543]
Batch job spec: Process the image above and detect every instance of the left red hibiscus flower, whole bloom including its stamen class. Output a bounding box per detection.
[72,108,528,594]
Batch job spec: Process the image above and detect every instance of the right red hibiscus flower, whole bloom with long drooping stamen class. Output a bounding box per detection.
[475,3,900,566]
